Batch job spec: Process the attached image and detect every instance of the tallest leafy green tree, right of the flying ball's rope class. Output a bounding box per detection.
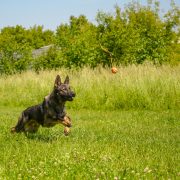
[94,1,180,64]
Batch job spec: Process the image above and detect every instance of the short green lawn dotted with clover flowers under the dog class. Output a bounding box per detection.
[0,107,180,179]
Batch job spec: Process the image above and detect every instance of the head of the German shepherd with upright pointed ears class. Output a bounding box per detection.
[54,75,76,101]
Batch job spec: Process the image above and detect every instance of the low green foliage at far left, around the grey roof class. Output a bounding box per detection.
[0,25,54,74]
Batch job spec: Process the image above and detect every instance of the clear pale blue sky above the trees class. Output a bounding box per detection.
[0,0,180,31]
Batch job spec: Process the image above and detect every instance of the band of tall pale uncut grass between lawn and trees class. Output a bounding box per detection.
[0,64,180,110]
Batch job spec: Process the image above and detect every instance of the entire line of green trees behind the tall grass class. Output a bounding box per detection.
[0,0,180,74]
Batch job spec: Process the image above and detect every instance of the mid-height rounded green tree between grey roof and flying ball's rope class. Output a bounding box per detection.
[56,15,100,67]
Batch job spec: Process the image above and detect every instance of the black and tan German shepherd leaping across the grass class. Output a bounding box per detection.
[10,75,76,136]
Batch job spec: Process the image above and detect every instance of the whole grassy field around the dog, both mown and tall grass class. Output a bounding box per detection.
[0,65,180,180]
